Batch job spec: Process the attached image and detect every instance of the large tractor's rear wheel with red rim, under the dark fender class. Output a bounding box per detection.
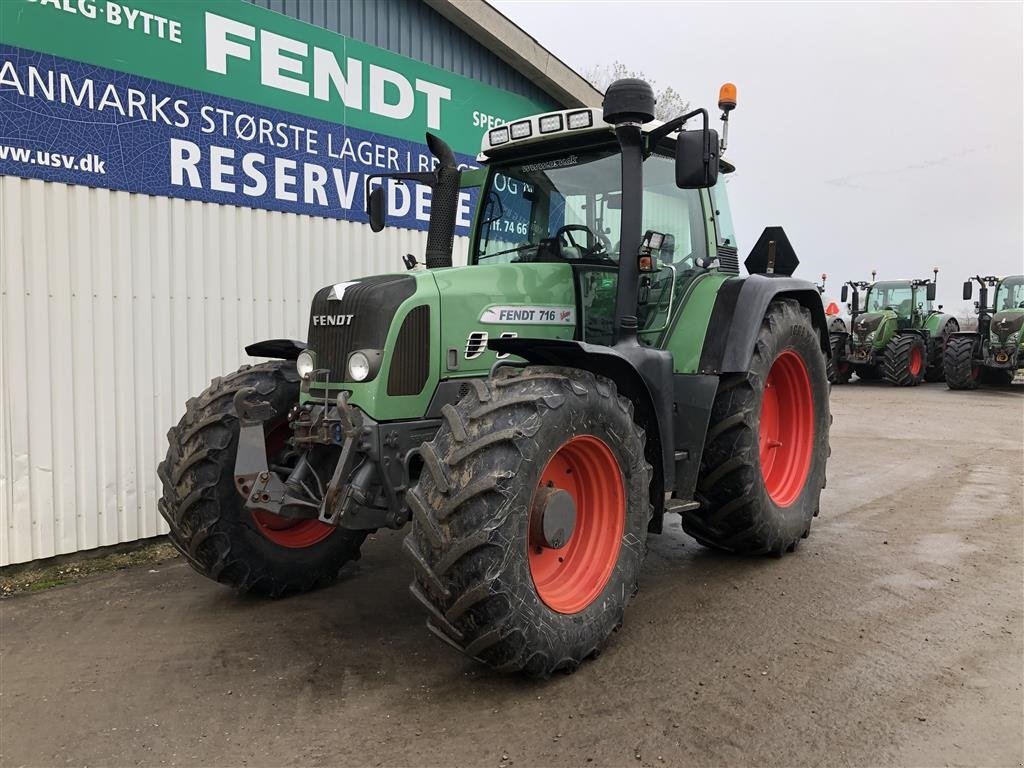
[683,299,831,555]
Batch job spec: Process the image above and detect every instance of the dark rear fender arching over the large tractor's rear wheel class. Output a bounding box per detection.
[698,274,831,374]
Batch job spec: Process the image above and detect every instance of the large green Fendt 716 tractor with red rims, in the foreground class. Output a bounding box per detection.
[160,80,830,677]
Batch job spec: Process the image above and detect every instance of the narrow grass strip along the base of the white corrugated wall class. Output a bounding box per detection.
[0,539,178,598]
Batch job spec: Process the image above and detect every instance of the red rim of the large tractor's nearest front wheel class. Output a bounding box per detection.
[526,435,626,613]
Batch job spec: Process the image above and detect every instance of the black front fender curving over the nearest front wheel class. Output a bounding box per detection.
[487,337,676,532]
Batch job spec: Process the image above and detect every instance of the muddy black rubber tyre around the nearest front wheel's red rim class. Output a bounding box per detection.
[404,366,651,677]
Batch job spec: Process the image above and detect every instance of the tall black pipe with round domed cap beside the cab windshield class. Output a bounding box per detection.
[602,78,654,346]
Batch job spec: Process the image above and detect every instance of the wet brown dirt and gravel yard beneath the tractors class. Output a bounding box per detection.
[0,384,1024,767]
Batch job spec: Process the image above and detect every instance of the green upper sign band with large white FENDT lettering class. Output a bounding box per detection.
[0,0,553,155]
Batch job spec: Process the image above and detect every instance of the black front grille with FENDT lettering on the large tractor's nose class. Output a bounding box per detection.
[307,274,416,382]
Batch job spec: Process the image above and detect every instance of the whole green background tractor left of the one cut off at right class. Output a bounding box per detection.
[831,267,959,387]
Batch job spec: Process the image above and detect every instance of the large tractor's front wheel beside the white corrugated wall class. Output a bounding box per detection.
[158,360,367,597]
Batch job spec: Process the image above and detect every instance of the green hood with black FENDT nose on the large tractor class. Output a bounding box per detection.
[302,263,578,421]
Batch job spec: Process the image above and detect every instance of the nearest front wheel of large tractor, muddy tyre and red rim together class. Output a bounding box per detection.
[404,367,651,677]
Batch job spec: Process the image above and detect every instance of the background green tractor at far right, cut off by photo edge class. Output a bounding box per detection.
[944,274,1024,389]
